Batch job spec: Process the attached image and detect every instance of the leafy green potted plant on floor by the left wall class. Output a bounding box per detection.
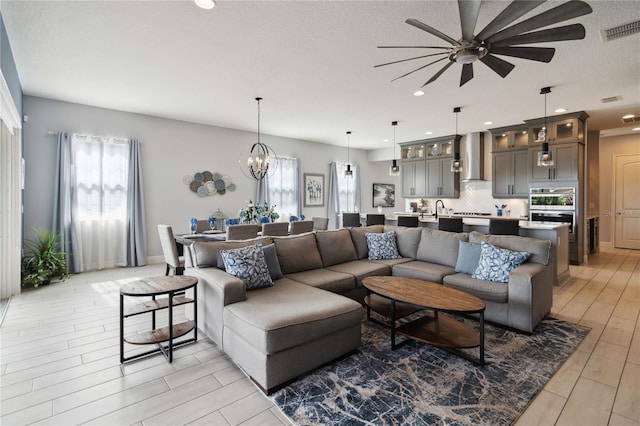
[22,229,70,287]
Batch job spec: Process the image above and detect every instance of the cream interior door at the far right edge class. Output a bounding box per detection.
[613,154,640,249]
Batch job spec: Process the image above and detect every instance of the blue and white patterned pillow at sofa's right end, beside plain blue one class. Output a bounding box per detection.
[471,241,529,283]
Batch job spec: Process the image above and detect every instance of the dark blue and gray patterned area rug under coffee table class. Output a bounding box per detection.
[271,314,589,425]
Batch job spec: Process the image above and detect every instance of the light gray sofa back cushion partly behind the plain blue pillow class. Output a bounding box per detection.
[416,228,469,268]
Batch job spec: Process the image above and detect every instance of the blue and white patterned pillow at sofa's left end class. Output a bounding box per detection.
[220,243,273,290]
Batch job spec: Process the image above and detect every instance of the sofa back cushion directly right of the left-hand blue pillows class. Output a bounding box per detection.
[273,234,322,275]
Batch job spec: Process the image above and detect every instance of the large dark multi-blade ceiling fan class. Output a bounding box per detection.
[374,0,593,87]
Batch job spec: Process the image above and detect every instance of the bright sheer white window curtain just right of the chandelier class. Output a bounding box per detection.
[266,158,301,221]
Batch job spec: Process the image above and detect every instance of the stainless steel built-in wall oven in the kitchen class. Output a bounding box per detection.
[529,188,577,242]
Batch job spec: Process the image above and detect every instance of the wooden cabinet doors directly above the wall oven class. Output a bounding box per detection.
[529,143,582,182]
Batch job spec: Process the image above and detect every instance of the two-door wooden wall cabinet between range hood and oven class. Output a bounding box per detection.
[492,149,529,198]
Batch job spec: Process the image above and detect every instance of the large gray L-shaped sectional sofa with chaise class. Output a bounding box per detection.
[185,225,554,393]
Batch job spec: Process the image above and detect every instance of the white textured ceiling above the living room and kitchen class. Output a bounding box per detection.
[0,0,640,149]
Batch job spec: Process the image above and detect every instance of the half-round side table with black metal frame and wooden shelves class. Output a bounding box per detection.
[120,275,198,363]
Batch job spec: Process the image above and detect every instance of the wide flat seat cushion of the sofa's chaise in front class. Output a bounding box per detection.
[223,277,362,355]
